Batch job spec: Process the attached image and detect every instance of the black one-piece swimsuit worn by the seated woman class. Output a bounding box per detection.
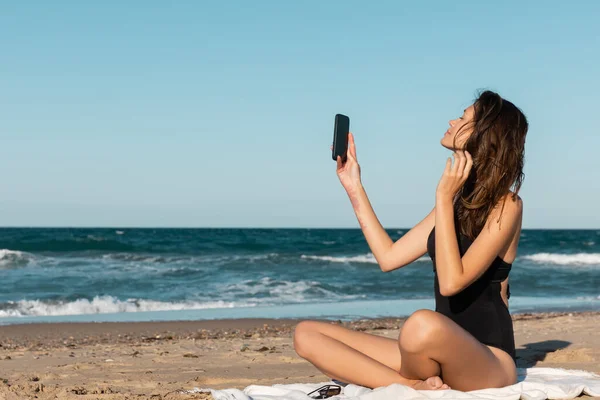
[427,226,516,361]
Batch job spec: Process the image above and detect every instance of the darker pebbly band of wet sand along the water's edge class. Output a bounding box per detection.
[0,311,600,349]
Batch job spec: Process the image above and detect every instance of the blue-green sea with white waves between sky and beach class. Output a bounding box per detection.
[0,228,600,325]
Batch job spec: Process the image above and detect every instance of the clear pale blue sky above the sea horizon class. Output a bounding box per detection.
[0,0,600,228]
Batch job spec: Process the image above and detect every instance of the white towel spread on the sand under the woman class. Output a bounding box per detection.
[188,367,600,400]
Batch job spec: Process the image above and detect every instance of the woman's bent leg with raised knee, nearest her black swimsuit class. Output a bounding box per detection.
[399,310,517,391]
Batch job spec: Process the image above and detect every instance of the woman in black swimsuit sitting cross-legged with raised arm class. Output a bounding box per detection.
[294,91,528,391]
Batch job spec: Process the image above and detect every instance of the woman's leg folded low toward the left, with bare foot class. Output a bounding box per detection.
[294,321,447,389]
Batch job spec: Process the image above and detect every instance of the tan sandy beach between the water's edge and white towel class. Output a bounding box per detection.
[0,312,600,400]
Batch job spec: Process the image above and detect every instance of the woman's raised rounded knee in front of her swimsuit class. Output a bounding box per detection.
[398,310,443,353]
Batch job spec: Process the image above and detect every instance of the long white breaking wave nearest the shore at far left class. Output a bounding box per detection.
[0,296,255,318]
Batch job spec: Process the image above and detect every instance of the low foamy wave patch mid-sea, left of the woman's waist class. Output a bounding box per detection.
[219,277,366,304]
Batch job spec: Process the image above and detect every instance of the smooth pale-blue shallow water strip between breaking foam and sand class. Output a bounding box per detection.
[0,296,600,326]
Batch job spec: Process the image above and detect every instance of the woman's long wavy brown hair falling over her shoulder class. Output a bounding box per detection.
[454,90,529,240]
